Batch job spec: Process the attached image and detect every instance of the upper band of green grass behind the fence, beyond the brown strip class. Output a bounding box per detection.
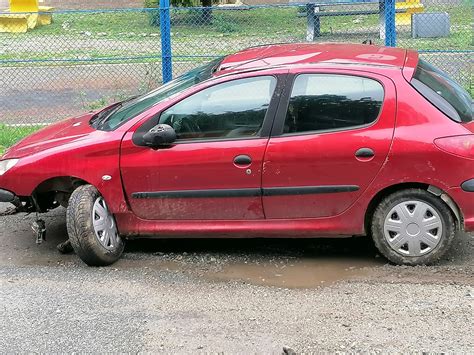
[0,2,474,60]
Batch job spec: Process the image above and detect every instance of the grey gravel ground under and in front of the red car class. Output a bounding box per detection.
[0,207,474,353]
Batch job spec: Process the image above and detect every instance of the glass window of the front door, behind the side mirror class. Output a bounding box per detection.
[159,76,277,140]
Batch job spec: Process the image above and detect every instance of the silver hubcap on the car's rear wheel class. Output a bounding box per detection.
[384,200,443,256]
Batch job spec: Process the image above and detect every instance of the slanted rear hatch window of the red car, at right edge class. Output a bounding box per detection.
[411,59,473,122]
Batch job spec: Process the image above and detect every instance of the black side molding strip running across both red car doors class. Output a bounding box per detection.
[132,185,359,199]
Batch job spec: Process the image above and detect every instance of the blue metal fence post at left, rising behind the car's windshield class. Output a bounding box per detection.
[159,0,173,83]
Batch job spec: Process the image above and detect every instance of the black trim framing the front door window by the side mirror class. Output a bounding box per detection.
[132,72,288,146]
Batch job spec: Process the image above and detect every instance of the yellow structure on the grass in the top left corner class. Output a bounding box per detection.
[0,0,54,33]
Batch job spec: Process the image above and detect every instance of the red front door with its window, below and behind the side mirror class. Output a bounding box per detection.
[121,75,279,220]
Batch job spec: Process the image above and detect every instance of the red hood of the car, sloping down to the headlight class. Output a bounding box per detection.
[2,114,95,159]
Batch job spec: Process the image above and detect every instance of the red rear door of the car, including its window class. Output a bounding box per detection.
[262,71,396,218]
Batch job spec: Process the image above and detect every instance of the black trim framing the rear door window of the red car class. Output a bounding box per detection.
[270,71,387,138]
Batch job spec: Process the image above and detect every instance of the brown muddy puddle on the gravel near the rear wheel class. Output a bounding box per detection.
[205,258,383,288]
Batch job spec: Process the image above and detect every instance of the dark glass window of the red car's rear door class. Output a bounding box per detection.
[283,74,384,134]
